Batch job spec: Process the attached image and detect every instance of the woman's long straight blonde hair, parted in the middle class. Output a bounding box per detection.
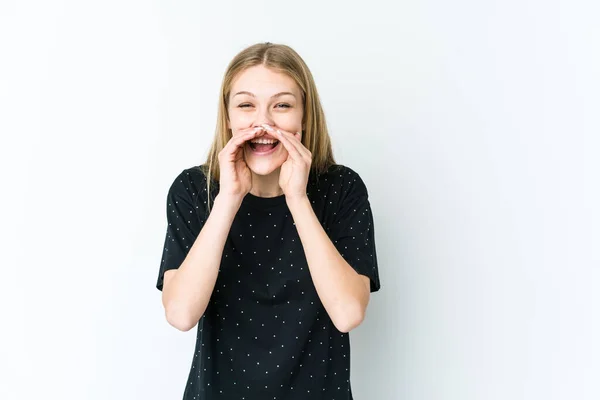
[202,42,335,209]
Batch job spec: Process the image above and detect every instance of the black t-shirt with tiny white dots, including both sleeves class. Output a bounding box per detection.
[156,165,380,400]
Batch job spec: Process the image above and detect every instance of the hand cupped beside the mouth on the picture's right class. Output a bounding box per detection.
[277,129,312,201]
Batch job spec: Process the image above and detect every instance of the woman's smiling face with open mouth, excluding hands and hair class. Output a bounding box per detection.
[227,65,304,175]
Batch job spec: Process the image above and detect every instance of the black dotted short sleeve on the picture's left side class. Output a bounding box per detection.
[156,170,206,290]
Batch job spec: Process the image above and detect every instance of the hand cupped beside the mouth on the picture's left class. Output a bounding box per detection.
[219,127,263,201]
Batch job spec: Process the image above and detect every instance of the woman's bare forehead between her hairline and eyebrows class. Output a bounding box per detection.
[231,65,300,97]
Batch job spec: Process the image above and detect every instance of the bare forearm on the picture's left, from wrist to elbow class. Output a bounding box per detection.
[163,195,241,330]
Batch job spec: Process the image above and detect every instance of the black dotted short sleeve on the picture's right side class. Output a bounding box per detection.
[330,170,381,292]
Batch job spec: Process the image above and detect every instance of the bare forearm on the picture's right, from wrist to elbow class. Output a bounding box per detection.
[288,198,369,332]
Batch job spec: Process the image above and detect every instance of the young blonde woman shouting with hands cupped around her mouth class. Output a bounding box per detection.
[157,43,380,400]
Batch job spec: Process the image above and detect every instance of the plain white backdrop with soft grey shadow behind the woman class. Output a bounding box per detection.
[0,0,600,400]
